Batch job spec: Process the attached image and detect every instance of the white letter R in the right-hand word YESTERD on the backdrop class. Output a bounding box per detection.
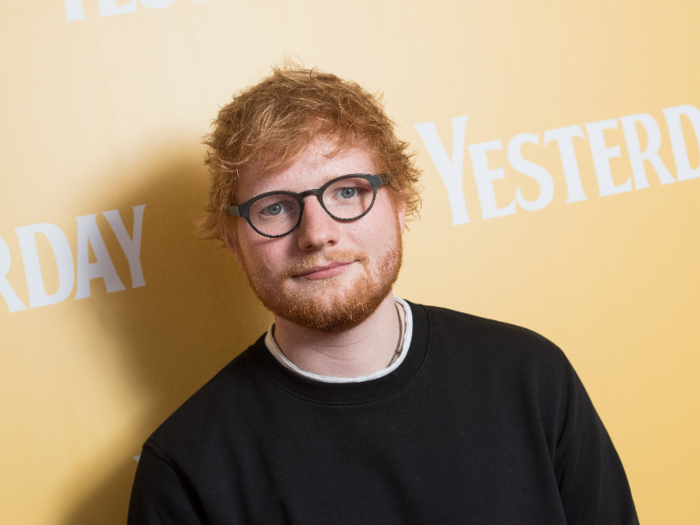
[620,113,676,190]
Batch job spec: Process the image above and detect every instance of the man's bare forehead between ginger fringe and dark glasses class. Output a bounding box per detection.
[236,138,376,203]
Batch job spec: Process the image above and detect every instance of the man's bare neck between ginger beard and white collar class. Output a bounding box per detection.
[274,293,404,377]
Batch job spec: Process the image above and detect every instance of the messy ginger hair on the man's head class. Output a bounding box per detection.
[199,63,420,239]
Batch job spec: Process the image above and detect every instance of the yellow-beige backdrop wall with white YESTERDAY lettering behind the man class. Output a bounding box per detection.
[0,0,700,525]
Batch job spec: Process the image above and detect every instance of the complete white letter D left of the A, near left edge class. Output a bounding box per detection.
[15,223,75,308]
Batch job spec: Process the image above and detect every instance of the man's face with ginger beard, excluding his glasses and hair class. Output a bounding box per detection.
[227,138,405,332]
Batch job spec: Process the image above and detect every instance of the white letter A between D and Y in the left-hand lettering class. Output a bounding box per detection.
[75,214,126,299]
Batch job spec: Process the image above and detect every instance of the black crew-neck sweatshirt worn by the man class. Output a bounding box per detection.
[129,304,637,525]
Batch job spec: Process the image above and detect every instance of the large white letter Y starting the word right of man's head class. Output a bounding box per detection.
[413,115,469,225]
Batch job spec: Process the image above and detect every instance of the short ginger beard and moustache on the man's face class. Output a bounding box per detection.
[238,219,403,332]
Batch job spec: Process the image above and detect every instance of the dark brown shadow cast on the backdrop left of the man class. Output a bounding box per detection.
[62,142,271,525]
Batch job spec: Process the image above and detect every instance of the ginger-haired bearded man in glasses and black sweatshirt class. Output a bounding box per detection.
[129,68,637,525]
